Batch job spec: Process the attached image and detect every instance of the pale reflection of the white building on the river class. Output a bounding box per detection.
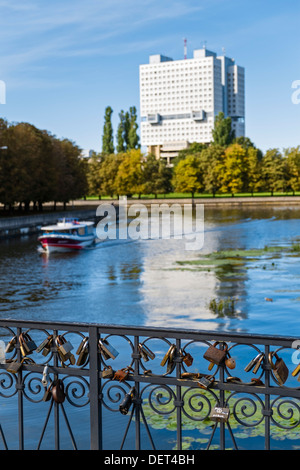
[140,211,247,330]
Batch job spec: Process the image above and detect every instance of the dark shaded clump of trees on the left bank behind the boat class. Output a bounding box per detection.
[0,119,88,211]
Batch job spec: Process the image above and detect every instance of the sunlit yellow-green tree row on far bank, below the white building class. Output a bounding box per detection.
[87,113,300,198]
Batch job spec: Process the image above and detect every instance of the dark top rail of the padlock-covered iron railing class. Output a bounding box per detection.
[0,318,300,347]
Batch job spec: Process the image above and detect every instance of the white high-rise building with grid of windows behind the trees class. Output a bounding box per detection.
[140,48,245,163]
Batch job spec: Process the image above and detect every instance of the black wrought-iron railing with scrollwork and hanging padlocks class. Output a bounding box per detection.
[0,320,300,450]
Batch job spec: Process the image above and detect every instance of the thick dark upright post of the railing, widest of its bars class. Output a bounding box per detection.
[89,326,102,450]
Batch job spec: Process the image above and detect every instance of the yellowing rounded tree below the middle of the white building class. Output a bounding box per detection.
[172,155,203,197]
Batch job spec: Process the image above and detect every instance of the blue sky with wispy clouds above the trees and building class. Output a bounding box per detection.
[0,0,300,152]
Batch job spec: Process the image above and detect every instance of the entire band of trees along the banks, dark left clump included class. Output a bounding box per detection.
[0,106,300,210]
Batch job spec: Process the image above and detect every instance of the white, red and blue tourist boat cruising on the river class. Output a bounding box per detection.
[38,219,96,253]
